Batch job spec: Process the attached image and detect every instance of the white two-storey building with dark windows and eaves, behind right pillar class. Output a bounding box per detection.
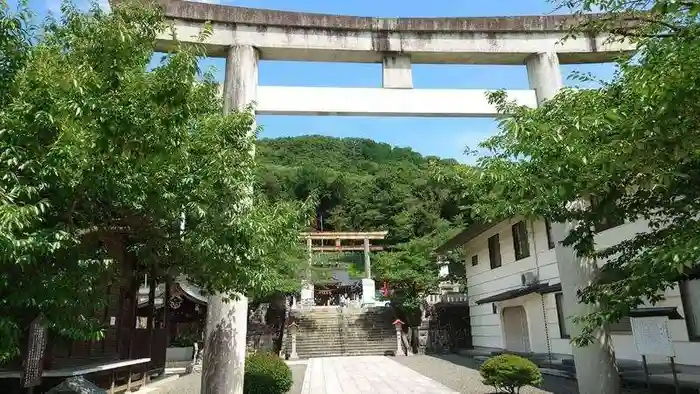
[439,217,700,365]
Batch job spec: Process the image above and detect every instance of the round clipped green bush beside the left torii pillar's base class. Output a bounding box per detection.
[243,353,292,394]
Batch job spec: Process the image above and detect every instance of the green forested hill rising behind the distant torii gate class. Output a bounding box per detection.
[256,136,465,244]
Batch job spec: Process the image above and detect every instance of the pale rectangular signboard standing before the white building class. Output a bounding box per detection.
[630,316,676,357]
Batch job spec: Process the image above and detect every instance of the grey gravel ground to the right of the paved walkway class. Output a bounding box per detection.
[393,355,645,394]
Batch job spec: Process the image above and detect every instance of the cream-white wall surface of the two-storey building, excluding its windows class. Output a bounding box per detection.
[463,217,700,365]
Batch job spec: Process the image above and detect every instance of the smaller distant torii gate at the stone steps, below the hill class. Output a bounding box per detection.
[300,231,388,306]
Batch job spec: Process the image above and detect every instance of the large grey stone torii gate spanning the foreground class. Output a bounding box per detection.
[117,0,633,394]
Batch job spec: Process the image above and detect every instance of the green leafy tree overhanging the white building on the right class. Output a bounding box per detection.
[458,0,700,345]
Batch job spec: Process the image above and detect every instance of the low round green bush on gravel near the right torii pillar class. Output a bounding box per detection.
[480,354,542,394]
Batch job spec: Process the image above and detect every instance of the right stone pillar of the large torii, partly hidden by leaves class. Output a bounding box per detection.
[526,50,620,394]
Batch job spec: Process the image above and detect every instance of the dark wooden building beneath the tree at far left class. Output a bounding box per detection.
[0,275,152,394]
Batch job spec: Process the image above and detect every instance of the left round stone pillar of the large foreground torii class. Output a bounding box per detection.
[201,45,258,394]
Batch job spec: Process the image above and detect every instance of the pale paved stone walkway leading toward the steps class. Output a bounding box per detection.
[301,356,457,394]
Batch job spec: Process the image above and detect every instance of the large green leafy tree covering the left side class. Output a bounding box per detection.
[0,3,307,362]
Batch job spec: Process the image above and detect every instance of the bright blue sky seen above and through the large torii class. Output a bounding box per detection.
[24,0,613,163]
